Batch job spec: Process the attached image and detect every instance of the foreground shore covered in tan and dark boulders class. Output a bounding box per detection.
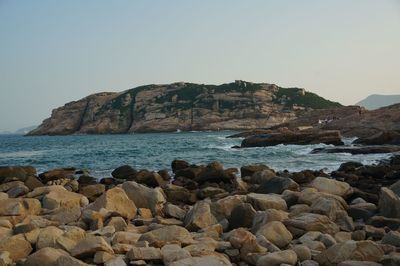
[0,155,400,266]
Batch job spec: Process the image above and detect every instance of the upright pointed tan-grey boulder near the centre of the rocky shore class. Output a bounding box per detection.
[183,200,218,231]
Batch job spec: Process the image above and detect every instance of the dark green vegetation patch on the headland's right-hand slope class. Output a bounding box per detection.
[274,88,342,109]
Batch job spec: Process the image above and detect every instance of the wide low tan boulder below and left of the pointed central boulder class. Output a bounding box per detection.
[139,225,194,247]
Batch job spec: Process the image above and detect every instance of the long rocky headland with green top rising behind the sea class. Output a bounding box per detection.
[28,81,340,135]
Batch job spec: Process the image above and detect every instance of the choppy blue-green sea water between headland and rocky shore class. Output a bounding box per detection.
[0,131,390,178]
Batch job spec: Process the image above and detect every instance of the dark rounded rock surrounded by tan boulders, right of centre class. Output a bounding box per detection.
[228,203,256,229]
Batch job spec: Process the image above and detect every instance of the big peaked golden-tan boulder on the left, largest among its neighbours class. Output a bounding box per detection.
[89,187,137,220]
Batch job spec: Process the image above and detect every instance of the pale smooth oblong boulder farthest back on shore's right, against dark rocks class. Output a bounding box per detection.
[310,176,353,197]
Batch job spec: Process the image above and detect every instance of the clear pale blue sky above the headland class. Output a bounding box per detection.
[0,0,400,131]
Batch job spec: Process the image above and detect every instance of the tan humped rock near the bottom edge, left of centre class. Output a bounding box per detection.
[71,236,114,258]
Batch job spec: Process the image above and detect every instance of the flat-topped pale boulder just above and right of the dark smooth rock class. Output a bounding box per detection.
[247,193,287,211]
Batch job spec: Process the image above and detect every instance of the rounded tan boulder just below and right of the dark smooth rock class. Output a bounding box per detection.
[256,221,293,248]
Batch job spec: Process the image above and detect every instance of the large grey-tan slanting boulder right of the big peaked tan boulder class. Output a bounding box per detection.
[122,181,167,215]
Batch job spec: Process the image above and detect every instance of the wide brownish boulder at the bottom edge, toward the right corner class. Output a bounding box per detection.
[315,240,385,266]
